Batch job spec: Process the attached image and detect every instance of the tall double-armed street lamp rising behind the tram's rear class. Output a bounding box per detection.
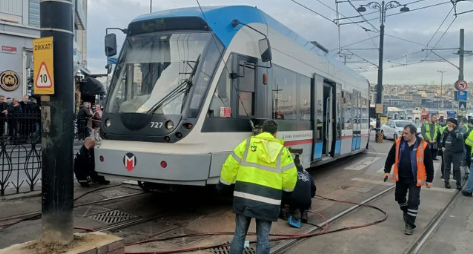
[357,1,409,142]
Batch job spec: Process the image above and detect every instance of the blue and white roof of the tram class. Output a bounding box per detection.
[132,5,366,80]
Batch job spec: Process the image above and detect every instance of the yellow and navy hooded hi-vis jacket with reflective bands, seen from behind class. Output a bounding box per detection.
[220,133,297,221]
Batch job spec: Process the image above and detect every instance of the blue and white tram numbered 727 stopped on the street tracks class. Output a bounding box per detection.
[95,6,369,190]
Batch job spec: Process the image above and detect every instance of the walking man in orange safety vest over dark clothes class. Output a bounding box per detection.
[384,124,434,235]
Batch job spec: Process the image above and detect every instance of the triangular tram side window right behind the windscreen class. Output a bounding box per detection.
[207,55,234,117]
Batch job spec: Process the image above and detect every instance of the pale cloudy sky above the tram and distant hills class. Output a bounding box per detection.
[87,0,473,85]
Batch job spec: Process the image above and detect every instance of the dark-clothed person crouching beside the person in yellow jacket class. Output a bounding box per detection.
[284,155,317,228]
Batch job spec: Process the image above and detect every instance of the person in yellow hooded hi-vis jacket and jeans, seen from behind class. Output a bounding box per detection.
[217,120,297,254]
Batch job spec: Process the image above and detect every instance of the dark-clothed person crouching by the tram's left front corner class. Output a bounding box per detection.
[74,137,110,187]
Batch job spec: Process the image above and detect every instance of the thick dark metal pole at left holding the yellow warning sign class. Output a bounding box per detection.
[40,0,74,244]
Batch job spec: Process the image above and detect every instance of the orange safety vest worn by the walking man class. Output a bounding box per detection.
[393,138,427,186]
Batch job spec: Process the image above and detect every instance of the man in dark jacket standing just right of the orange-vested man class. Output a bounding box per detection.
[440,118,464,190]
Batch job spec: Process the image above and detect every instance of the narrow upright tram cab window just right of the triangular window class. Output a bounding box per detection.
[238,60,256,116]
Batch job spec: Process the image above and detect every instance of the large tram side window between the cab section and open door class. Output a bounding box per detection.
[272,65,296,120]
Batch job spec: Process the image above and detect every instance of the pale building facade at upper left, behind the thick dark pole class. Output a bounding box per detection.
[0,0,87,100]
